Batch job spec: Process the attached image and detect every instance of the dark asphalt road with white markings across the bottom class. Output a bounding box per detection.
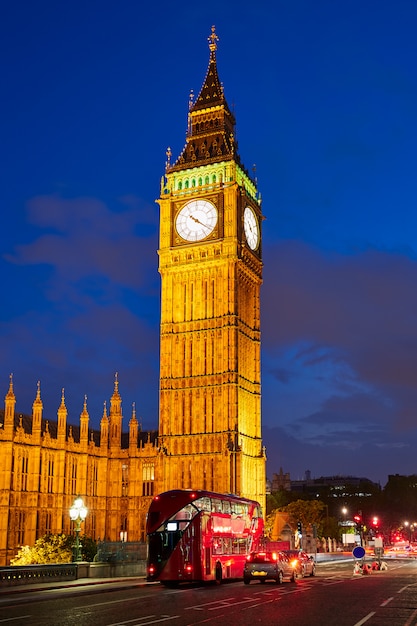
[0,560,417,626]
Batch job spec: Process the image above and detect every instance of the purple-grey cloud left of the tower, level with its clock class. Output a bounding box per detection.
[5,196,158,289]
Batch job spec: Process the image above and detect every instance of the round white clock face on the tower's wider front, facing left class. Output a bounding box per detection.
[175,200,217,241]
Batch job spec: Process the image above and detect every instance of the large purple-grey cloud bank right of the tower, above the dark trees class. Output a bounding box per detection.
[262,241,417,482]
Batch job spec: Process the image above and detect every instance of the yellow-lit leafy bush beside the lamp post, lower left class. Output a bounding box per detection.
[11,533,74,565]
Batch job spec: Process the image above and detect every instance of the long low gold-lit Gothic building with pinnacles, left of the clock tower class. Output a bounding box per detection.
[0,379,162,566]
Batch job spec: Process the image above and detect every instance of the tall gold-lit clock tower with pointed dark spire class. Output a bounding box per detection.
[158,27,265,505]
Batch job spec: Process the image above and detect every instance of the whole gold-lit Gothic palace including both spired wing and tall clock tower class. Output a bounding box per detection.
[0,27,266,565]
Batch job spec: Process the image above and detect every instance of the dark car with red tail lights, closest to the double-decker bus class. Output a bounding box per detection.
[243,551,295,585]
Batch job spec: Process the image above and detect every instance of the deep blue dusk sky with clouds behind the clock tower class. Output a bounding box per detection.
[0,0,417,486]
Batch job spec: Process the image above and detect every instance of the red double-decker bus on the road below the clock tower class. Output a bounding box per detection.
[146,489,264,585]
